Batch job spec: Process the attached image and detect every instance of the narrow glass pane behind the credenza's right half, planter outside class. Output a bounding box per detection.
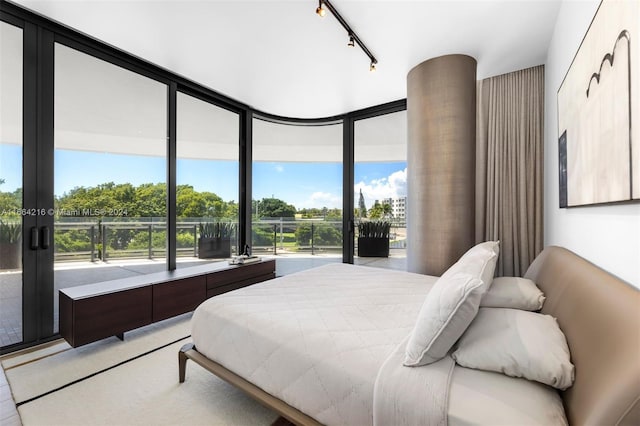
[176,92,240,268]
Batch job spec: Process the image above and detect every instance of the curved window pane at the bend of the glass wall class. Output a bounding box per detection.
[252,118,343,259]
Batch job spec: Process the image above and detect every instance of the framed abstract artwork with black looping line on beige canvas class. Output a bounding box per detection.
[558,0,640,207]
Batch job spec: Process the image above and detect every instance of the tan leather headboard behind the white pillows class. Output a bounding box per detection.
[525,247,640,425]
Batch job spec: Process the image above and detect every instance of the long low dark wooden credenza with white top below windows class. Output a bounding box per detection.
[59,259,276,347]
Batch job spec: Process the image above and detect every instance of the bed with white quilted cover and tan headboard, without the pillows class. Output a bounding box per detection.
[179,247,640,426]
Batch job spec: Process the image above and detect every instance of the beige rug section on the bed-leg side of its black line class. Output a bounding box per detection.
[18,339,278,426]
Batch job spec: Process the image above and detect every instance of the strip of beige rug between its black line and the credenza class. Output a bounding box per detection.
[2,313,191,403]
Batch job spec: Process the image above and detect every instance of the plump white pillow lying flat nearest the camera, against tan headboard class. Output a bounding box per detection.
[451,308,575,390]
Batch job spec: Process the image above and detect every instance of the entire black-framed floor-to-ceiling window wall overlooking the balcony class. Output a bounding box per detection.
[0,3,408,351]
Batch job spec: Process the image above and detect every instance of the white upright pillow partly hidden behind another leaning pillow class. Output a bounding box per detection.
[442,241,500,291]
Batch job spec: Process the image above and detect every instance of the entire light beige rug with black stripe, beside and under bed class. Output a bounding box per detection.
[2,314,278,426]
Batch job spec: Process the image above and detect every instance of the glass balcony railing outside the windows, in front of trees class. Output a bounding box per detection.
[54,218,406,262]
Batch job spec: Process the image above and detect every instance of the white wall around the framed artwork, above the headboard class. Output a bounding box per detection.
[544,0,640,288]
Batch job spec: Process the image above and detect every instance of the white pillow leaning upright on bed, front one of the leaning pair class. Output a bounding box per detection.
[403,272,484,367]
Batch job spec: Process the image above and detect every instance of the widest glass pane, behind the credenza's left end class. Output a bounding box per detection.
[53,43,168,332]
